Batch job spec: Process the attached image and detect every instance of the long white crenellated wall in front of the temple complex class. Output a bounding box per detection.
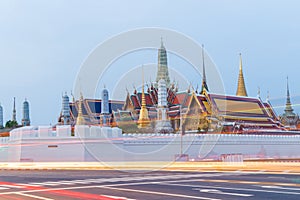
[0,126,300,162]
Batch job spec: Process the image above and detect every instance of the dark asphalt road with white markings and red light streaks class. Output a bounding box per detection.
[0,170,300,200]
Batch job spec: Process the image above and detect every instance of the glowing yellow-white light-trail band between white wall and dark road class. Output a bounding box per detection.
[0,162,300,174]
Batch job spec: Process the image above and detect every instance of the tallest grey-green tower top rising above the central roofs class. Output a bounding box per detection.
[156,38,170,87]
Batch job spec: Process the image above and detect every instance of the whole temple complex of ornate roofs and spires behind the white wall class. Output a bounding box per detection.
[58,41,299,134]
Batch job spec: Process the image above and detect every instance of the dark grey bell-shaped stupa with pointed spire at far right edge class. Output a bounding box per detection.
[280,78,300,129]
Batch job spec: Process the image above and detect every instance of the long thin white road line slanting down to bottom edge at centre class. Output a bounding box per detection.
[97,186,219,200]
